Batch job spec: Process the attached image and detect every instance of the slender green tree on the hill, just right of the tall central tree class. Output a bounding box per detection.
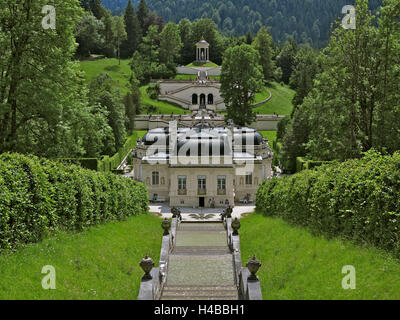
[253,27,274,82]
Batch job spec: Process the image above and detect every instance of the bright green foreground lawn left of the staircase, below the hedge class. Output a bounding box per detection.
[0,214,162,300]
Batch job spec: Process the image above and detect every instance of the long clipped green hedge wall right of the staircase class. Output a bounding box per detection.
[256,151,400,257]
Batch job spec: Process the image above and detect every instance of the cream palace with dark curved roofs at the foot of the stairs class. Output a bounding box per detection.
[134,121,273,207]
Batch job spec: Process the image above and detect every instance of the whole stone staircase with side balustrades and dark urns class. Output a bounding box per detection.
[139,208,261,300]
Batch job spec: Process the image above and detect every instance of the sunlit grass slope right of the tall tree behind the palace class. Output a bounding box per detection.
[254,83,295,115]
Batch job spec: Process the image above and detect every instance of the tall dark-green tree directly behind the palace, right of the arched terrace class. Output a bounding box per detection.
[221,44,263,126]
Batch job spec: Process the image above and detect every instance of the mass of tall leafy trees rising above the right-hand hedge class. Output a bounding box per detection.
[283,0,400,165]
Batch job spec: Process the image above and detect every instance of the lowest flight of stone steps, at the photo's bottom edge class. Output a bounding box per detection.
[161,285,238,300]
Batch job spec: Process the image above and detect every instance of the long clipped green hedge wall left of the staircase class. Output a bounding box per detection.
[0,154,148,249]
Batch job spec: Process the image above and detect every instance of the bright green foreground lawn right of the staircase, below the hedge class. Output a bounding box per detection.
[240,213,400,300]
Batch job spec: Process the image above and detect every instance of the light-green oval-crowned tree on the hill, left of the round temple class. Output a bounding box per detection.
[160,22,182,66]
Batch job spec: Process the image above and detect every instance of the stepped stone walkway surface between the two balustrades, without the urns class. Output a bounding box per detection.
[161,222,238,300]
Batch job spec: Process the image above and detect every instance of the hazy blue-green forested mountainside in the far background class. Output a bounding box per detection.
[103,0,382,47]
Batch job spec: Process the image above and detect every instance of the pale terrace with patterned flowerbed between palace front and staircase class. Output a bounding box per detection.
[149,203,255,221]
